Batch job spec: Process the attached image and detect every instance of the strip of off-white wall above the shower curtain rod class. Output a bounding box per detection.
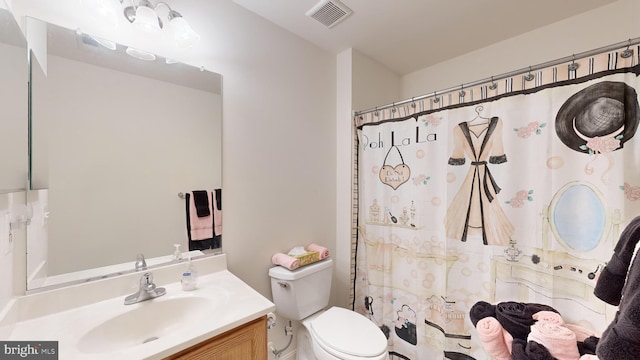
[398,0,640,100]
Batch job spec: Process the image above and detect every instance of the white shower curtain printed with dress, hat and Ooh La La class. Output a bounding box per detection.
[353,49,640,360]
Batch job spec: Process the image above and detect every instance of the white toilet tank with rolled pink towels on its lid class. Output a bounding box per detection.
[269,259,333,320]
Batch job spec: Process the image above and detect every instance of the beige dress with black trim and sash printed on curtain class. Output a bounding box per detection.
[445,117,515,245]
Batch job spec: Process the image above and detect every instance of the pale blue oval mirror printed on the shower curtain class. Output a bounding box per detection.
[549,181,610,252]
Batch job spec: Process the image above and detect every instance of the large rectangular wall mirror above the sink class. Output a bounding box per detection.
[27,19,222,290]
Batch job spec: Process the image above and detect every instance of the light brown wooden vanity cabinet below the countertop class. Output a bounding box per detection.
[165,316,267,360]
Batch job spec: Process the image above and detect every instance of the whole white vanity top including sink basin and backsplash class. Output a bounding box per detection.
[5,255,275,360]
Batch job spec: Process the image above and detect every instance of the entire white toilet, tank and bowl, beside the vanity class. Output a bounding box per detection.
[269,259,389,360]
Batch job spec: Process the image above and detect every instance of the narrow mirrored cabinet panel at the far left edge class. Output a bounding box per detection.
[0,5,29,194]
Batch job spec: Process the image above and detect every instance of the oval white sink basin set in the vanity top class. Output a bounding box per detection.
[78,295,212,353]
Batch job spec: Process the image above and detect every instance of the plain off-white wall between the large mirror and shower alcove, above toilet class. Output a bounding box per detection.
[212,6,336,297]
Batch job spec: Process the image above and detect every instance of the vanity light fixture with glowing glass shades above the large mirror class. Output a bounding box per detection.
[118,0,200,50]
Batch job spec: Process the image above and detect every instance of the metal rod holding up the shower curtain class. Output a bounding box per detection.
[354,37,640,116]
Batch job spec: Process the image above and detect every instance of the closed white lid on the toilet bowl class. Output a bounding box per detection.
[310,307,387,357]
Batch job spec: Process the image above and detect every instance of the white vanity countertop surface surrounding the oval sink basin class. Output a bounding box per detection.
[6,255,275,360]
